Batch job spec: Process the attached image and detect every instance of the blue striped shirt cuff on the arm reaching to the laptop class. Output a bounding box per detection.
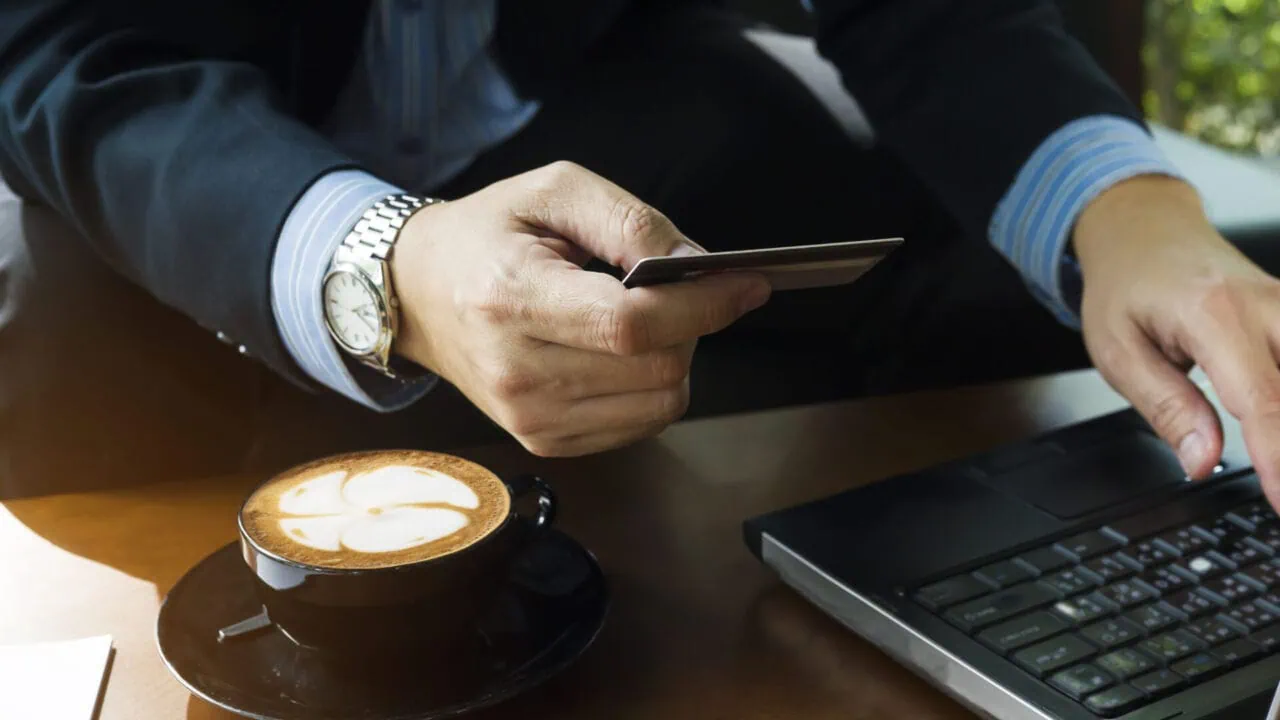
[989,115,1181,327]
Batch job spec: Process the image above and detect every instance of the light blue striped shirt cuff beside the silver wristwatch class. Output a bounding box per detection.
[271,170,438,413]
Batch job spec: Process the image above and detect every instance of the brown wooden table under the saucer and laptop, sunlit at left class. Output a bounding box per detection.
[0,373,1121,720]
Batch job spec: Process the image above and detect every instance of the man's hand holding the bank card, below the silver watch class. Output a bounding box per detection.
[392,163,769,456]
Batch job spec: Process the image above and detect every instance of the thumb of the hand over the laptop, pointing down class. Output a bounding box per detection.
[1089,331,1222,479]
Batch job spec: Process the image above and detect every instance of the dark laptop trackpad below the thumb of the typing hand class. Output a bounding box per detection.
[978,430,1185,520]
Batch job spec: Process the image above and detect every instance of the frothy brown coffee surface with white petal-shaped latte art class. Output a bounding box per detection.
[241,451,511,570]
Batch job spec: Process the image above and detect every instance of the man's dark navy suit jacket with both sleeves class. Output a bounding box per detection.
[0,0,1137,380]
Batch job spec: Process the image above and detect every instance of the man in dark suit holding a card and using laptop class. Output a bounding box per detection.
[0,0,1280,501]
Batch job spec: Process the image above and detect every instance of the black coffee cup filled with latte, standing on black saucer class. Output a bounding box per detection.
[238,451,556,659]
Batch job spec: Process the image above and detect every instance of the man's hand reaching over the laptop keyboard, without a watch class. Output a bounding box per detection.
[1075,176,1280,507]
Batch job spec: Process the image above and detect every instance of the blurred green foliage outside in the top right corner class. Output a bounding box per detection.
[1143,0,1280,155]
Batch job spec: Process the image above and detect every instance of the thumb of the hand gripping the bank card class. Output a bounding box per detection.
[511,161,705,270]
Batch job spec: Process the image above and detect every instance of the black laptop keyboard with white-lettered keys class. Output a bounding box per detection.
[914,501,1280,717]
